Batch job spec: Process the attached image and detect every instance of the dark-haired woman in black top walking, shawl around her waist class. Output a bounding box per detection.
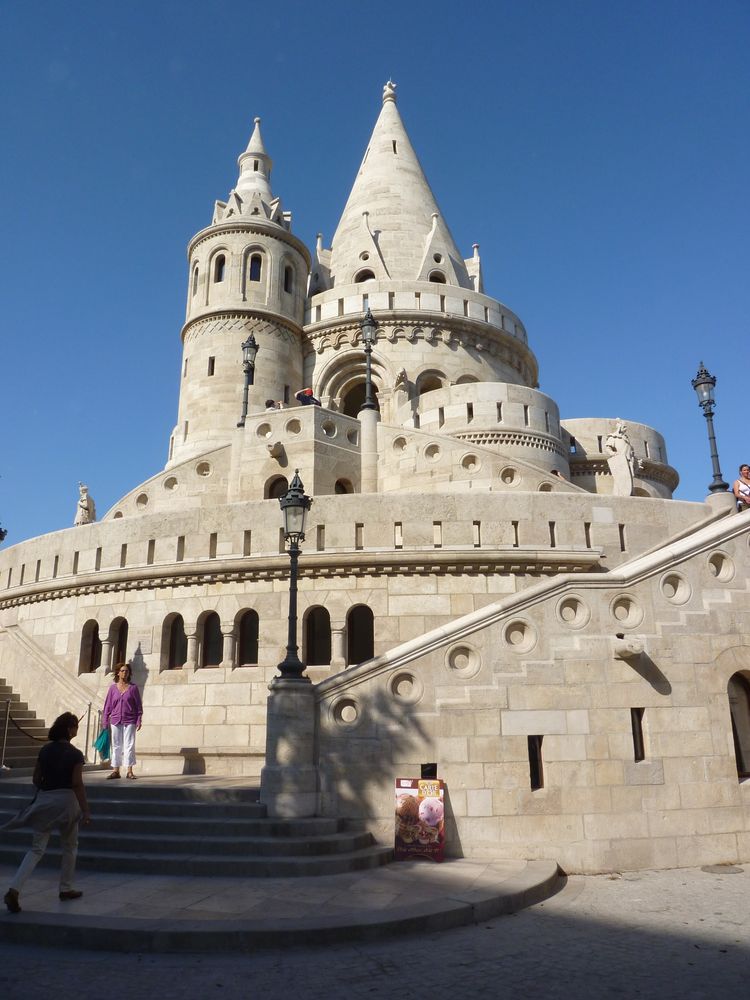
[3,712,91,913]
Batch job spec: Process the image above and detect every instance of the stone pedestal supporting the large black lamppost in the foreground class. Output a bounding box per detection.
[260,677,318,818]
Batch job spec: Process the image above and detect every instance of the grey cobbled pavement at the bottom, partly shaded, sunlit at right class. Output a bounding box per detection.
[0,865,750,1000]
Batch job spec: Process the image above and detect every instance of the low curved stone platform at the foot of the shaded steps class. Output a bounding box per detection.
[0,859,565,952]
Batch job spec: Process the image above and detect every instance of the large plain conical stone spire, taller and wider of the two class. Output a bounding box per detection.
[331,80,471,288]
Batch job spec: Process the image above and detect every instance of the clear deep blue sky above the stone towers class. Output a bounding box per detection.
[0,0,750,546]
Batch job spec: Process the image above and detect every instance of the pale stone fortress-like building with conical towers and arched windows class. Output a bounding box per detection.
[0,83,750,871]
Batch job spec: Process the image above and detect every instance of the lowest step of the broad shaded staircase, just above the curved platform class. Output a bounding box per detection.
[0,834,393,878]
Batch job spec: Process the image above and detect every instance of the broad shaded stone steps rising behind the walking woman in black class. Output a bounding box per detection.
[0,774,392,878]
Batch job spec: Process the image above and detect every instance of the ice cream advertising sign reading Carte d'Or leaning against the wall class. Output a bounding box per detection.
[395,778,445,861]
